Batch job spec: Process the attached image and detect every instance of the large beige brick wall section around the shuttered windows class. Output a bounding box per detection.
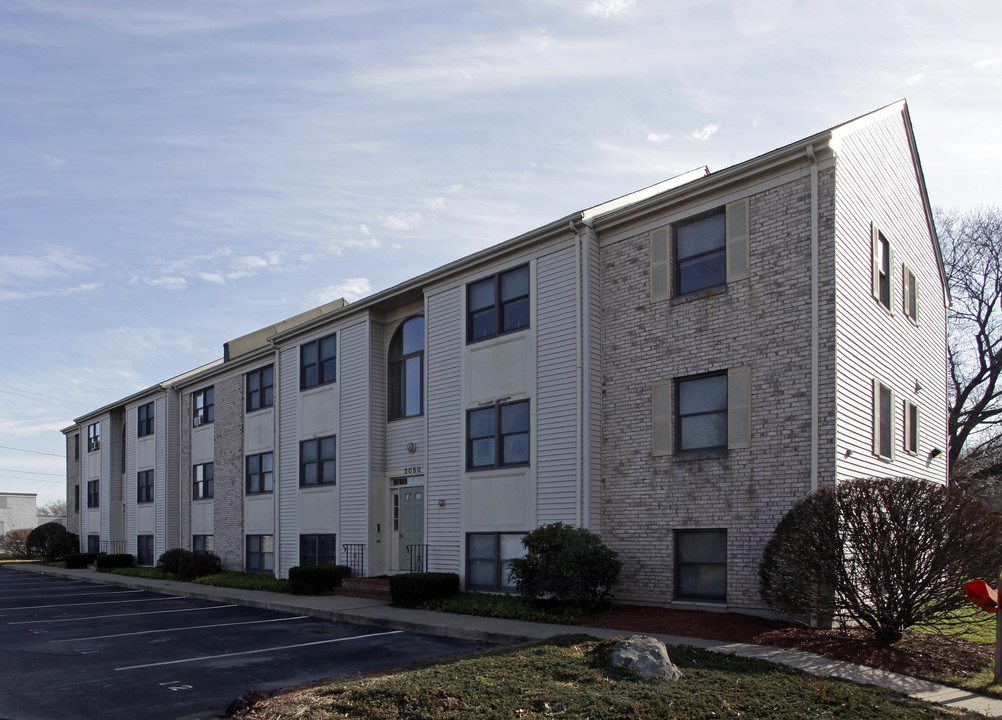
[601,167,834,608]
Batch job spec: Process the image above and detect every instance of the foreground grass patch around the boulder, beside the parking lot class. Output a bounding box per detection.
[251,635,973,720]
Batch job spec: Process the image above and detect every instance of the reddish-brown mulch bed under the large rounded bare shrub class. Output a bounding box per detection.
[582,605,995,678]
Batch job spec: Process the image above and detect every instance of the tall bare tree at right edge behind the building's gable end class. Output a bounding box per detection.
[936,207,1002,468]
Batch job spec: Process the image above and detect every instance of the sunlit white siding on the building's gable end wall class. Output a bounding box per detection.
[822,107,947,483]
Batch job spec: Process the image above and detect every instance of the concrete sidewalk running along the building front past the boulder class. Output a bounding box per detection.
[11,564,1002,717]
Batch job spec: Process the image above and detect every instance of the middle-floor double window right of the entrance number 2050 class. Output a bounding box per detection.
[466,400,529,470]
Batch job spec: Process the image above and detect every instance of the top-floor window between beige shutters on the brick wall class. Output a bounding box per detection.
[674,208,727,295]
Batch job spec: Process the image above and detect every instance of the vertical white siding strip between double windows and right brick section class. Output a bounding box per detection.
[541,245,581,530]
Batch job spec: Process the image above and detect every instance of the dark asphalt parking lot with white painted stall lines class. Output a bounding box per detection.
[0,568,488,720]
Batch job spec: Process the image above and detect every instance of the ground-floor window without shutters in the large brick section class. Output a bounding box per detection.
[675,530,727,602]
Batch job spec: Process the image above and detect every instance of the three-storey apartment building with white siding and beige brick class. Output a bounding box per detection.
[64,102,948,610]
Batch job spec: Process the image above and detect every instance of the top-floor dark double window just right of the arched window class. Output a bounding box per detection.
[466,265,529,342]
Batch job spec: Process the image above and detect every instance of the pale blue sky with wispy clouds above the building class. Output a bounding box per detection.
[0,0,1002,505]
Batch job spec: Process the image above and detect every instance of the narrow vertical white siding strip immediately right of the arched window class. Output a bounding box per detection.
[425,286,466,573]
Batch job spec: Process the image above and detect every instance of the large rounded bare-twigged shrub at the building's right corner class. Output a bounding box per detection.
[760,478,1002,643]
